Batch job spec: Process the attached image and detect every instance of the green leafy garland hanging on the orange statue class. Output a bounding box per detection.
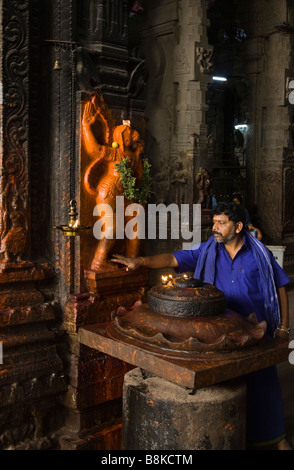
[115,157,151,204]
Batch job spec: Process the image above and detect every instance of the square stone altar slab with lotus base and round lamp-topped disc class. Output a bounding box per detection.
[78,277,288,389]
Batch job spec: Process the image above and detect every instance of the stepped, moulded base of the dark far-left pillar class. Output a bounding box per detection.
[0,262,66,450]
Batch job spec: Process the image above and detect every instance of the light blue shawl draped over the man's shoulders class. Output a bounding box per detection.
[194,232,281,334]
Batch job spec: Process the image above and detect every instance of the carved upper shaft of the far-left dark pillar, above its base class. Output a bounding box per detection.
[0,1,29,265]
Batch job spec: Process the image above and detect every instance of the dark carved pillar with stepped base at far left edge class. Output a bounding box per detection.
[0,0,65,449]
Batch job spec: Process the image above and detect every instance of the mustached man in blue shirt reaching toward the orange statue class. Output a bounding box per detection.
[112,203,291,449]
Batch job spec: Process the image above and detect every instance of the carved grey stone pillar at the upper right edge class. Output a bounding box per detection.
[238,1,294,258]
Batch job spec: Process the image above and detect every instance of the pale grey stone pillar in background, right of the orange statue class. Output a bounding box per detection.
[142,0,212,260]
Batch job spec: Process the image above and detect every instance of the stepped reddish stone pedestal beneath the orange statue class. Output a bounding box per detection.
[59,269,148,450]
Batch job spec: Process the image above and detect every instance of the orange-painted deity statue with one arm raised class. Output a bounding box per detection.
[82,95,144,269]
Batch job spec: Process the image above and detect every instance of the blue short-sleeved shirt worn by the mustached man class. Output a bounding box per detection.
[173,239,290,321]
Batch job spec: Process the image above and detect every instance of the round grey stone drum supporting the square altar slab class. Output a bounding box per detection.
[123,368,246,450]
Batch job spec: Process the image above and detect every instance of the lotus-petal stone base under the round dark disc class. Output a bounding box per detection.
[112,304,266,359]
